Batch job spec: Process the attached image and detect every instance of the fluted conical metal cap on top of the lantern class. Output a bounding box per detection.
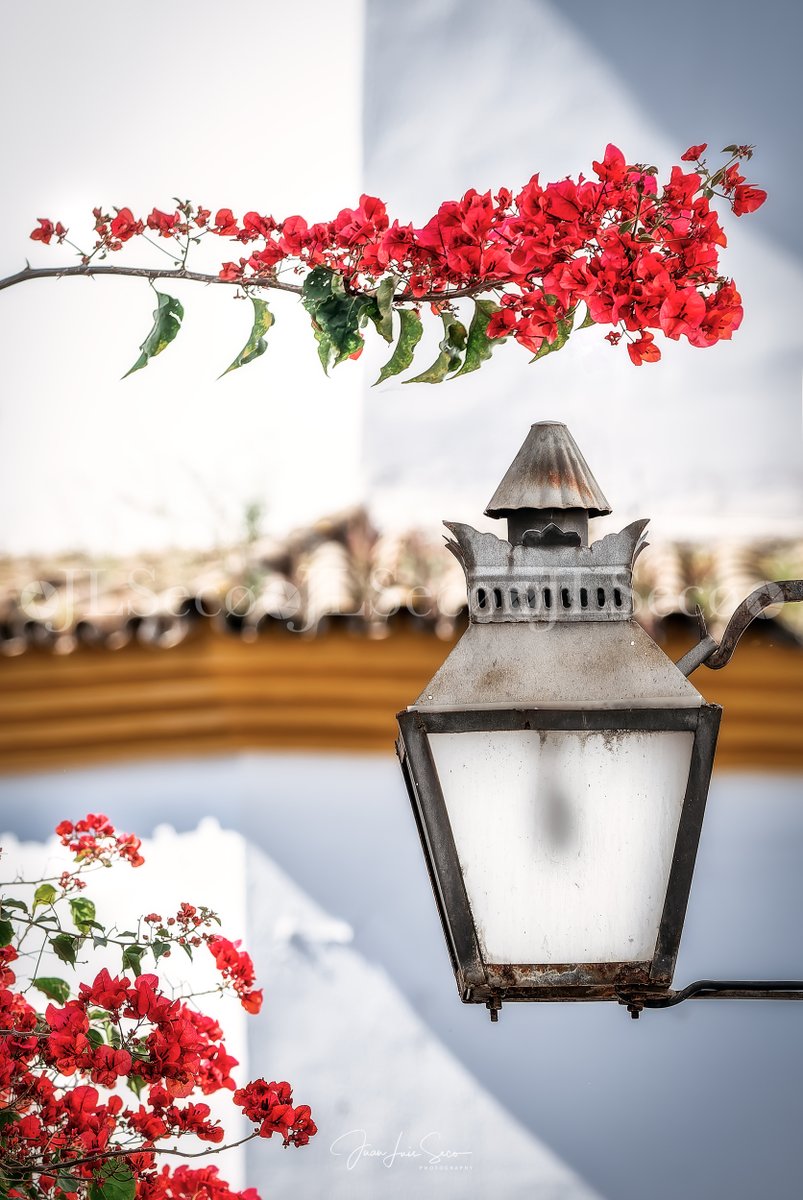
[485,421,611,517]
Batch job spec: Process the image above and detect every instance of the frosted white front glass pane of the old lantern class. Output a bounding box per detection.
[430,731,694,964]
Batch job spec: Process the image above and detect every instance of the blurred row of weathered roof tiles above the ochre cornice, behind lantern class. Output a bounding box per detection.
[0,510,803,655]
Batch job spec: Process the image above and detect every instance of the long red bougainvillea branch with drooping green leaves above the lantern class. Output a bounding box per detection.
[7,143,766,383]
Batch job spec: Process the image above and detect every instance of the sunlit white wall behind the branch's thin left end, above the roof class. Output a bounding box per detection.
[0,0,364,554]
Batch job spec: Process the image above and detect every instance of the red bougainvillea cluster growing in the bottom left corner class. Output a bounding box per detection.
[0,814,317,1200]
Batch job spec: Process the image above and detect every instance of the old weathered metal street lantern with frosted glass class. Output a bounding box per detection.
[397,422,803,1020]
